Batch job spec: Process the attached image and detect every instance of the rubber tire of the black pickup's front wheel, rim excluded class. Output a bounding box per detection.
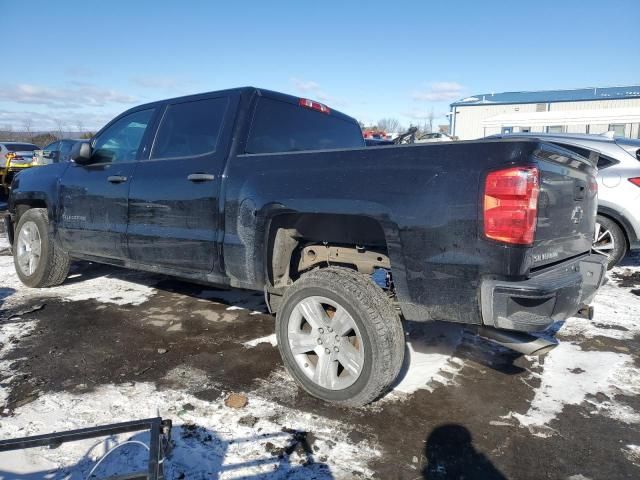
[13,208,69,288]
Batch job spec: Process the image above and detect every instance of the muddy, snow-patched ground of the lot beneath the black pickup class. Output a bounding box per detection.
[0,231,640,480]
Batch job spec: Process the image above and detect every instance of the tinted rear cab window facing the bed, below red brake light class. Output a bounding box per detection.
[246,97,364,153]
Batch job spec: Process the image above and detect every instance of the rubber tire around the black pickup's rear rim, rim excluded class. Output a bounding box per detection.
[276,267,405,406]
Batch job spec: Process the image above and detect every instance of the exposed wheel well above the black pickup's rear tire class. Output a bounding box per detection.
[267,213,389,288]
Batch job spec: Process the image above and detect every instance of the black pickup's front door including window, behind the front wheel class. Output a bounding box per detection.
[58,108,154,259]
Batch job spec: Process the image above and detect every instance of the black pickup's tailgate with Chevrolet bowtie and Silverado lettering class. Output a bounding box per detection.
[530,144,598,270]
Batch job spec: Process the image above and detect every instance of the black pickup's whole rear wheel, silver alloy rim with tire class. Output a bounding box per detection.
[276,267,404,406]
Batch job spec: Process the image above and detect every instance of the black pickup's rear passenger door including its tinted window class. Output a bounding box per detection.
[127,94,237,273]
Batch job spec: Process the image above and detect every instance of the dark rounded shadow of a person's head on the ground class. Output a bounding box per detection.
[421,423,507,480]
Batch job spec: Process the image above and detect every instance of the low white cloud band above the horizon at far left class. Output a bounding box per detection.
[0,82,136,108]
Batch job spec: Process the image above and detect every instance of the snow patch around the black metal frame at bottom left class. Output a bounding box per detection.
[0,383,381,480]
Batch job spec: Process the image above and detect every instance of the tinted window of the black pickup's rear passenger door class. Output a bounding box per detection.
[151,97,229,159]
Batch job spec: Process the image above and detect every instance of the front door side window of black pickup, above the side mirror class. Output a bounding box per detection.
[92,109,153,163]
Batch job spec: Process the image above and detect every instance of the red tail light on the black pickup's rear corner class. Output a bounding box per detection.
[483,167,540,245]
